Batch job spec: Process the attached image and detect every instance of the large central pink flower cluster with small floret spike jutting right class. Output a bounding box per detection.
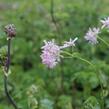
[41,38,77,68]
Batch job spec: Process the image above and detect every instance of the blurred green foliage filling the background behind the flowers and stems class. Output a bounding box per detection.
[0,0,109,109]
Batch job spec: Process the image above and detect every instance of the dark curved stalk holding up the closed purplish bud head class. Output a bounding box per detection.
[4,39,18,109]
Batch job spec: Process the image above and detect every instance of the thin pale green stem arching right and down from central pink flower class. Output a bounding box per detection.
[62,51,104,109]
